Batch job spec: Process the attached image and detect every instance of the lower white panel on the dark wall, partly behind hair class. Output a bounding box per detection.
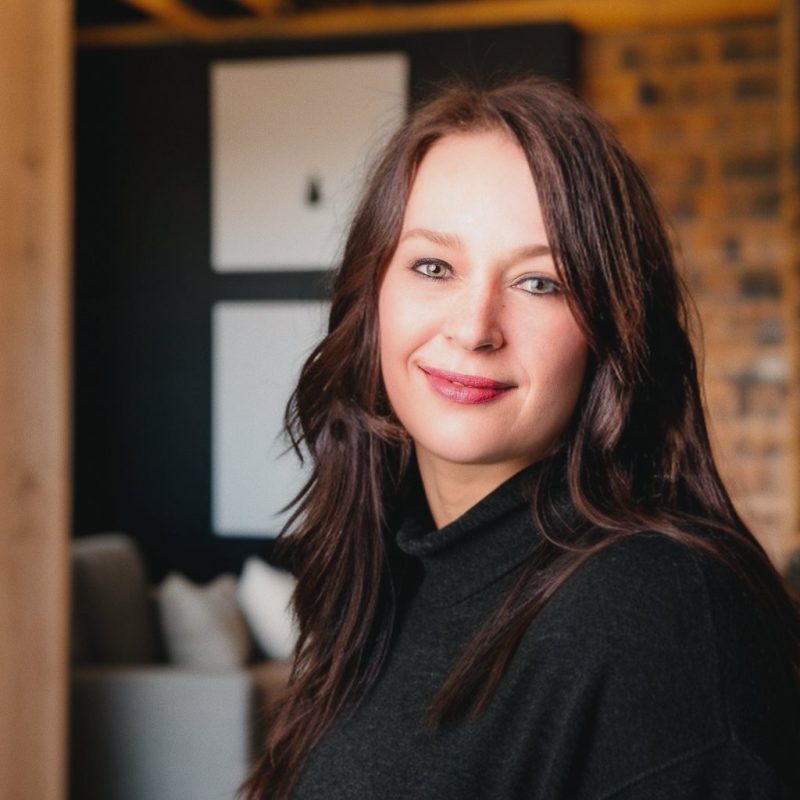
[211,300,329,536]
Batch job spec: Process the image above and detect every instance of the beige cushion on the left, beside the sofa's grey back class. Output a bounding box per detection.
[158,573,251,670]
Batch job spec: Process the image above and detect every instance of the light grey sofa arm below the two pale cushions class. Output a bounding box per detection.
[70,663,288,800]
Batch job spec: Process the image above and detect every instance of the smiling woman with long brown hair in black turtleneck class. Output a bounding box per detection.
[245,79,800,800]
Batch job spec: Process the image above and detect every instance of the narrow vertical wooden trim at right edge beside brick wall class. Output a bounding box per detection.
[780,0,800,559]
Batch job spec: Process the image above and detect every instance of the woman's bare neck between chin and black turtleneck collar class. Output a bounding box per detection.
[417,448,528,528]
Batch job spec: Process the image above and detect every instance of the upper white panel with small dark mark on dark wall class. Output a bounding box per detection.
[210,53,409,272]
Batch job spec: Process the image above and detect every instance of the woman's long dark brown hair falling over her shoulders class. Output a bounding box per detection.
[243,78,800,800]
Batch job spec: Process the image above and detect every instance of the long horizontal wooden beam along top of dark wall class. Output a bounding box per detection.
[77,0,780,47]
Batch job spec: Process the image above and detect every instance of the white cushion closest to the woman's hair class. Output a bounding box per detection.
[237,557,297,659]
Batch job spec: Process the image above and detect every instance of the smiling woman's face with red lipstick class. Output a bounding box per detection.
[378,133,587,476]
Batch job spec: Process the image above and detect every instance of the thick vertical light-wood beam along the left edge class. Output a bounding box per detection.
[0,0,72,800]
